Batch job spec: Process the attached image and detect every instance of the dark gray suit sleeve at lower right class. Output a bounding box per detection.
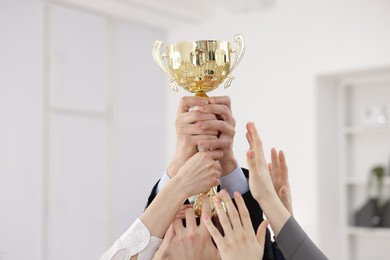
[275,216,328,260]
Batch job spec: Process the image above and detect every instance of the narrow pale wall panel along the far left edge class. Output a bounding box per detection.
[0,0,45,260]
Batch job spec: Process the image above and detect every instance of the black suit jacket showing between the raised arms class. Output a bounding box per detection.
[145,168,284,260]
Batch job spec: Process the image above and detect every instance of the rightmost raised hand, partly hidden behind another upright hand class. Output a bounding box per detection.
[268,148,293,215]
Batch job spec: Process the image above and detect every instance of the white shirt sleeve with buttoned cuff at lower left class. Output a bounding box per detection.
[100,218,162,260]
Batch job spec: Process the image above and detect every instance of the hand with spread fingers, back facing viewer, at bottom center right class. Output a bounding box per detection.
[202,190,268,260]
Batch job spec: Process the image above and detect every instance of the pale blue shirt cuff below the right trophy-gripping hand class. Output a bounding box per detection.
[221,165,249,198]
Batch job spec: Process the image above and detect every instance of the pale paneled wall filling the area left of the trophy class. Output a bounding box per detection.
[0,0,165,260]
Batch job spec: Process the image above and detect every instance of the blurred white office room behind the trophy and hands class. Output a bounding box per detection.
[0,0,390,260]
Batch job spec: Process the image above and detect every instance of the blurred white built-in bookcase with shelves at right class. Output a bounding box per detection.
[316,68,390,260]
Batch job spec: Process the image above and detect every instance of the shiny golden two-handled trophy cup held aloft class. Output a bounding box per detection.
[152,34,245,216]
